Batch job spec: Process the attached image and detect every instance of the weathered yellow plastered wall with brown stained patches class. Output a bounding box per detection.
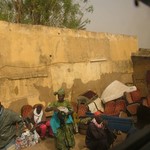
[0,21,138,111]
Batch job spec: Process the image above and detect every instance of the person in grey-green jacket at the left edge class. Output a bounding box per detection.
[0,102,24,150]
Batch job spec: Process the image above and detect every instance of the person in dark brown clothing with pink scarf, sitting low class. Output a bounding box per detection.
[85,116,109,150]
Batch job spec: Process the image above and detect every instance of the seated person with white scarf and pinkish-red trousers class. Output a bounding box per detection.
[29,104,53,140]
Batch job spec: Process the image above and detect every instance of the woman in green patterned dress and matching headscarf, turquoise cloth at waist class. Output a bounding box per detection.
[45,88,75,150]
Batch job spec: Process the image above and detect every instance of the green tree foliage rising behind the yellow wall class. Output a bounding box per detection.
[0,0,93,29]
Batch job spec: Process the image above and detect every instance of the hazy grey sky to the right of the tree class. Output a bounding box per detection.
[86,0,150,49]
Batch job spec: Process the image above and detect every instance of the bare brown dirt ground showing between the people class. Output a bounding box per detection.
[25,133,126,150]
